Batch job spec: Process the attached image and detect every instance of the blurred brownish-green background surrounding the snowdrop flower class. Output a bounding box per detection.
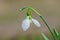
[0,0,60,40]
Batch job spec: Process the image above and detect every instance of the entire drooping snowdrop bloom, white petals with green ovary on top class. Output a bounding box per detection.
[22,10,41,31]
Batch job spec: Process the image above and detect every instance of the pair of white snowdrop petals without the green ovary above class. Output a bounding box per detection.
[22,17,41,31]
